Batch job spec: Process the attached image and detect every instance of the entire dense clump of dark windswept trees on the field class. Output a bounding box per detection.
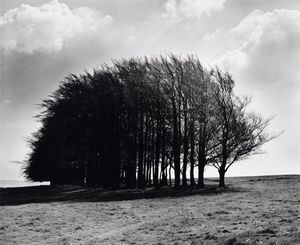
[24,55,273,189]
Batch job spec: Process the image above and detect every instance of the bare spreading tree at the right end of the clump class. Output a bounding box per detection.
[212,69,276,187]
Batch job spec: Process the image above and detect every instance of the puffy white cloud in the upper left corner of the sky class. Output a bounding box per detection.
[0,0,112,54]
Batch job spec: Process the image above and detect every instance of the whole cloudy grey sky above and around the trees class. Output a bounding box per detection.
[0,0,300,180]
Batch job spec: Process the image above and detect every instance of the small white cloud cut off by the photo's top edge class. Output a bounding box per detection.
[163,0,226,21]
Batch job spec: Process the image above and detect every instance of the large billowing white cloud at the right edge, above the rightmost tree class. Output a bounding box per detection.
[204,9,300,82]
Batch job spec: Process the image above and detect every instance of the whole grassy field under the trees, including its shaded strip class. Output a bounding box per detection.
[0,175,300,245]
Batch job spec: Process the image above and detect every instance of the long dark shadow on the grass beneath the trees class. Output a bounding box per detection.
[0,184,244,206]
